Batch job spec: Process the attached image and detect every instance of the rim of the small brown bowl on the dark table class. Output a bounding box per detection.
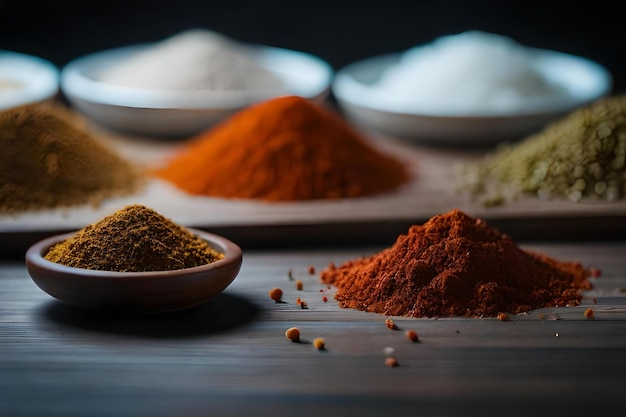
[25,228,243,280]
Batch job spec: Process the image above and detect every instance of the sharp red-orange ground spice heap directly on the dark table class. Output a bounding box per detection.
[320,210,591,317]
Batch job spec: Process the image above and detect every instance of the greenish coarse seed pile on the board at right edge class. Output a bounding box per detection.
[458,95,626,206]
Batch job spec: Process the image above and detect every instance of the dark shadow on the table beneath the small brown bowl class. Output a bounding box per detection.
[41,293,259,338]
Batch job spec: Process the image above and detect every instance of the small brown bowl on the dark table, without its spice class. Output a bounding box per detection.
[26,229,242,313]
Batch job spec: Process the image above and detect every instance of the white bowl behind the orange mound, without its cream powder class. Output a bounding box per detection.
[61,44,333,136]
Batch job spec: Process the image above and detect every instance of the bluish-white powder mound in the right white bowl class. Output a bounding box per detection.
[372,31,569,116]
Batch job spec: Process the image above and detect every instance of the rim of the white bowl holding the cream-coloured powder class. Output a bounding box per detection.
[60,42,334,110]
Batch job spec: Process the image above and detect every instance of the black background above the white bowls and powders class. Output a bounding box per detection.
[0,0,626,92]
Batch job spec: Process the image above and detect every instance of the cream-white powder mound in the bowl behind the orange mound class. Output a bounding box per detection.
[100,29,284,91]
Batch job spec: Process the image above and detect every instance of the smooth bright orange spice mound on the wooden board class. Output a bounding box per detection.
[153,96,410,201]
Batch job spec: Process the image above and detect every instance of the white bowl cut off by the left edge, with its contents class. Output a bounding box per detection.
[0,50,59,110]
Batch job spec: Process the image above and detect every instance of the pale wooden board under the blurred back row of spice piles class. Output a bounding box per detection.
[0,122,626,253]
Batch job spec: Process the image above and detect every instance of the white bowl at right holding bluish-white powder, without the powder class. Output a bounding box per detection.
[332,49,612,146]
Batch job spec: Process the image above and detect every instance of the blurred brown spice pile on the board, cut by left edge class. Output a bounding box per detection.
[0,104,144,213]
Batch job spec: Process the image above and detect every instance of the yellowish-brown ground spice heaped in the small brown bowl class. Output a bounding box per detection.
[44,205,224,272]
